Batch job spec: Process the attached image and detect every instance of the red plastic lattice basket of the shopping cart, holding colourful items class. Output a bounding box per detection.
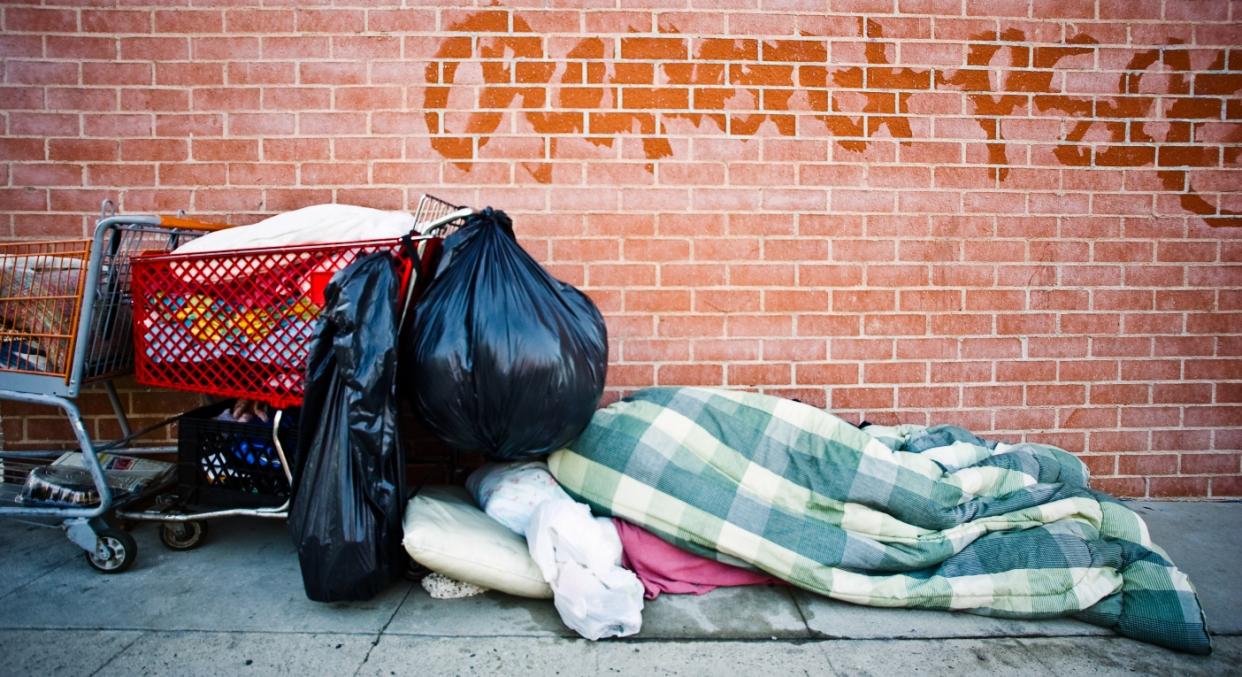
[133,240,417,407]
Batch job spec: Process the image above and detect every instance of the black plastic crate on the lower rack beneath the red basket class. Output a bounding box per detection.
[176,401,297,508]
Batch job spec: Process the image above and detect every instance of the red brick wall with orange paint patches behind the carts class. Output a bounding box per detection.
[0,0,1242,497]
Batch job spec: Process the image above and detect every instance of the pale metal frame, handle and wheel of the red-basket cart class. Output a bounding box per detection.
[117,195,474,550]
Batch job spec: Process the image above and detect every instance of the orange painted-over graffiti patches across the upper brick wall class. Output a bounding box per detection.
[424,12,1242,226]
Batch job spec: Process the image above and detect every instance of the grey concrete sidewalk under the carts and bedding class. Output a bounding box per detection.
[0,502,1242,676]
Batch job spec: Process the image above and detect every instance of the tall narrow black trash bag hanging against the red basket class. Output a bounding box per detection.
[289,253,405,601]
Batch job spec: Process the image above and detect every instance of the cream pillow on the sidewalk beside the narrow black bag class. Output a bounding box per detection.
[401,487,551,599]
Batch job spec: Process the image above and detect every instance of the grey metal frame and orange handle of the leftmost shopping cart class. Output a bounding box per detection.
[0,200,224,573]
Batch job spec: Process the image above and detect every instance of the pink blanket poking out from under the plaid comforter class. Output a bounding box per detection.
[612,519,784,600]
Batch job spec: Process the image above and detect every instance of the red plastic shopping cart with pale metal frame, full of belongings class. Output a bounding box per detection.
[124,195,473,550]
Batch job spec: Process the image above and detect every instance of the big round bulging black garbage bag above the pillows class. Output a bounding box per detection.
[402,207,609,460]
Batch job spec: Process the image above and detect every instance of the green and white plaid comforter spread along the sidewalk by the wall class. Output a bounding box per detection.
[548,388,1211,653]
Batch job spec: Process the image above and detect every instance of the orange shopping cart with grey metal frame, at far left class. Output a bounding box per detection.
[0,201,221,573]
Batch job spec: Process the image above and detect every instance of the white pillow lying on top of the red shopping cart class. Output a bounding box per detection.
[174,205,415,253]
